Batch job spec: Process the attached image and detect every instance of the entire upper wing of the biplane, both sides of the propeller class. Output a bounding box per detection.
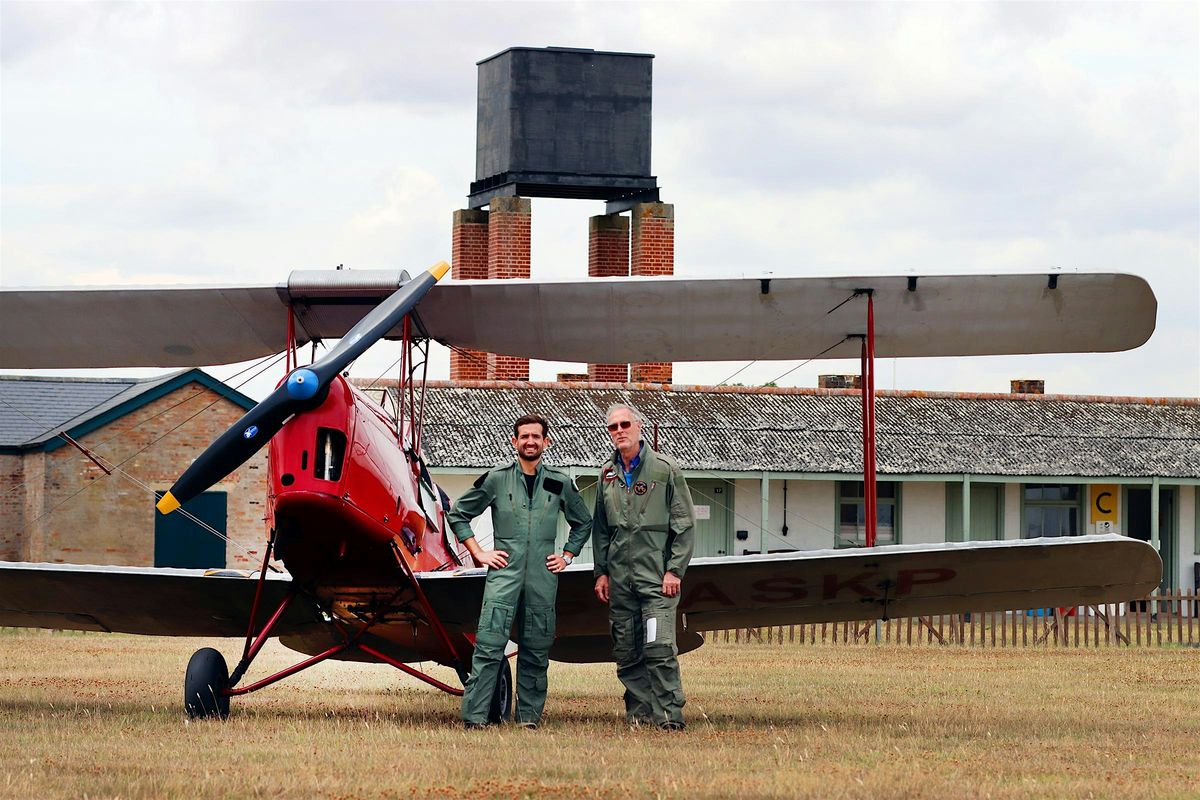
[0,270,1158,368]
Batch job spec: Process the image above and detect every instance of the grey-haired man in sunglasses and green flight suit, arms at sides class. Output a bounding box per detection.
[592,404,696,730]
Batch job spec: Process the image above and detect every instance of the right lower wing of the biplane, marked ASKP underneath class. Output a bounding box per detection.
[537,535,1163,651]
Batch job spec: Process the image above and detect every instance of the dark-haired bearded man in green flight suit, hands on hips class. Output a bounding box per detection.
[449,414,592,729]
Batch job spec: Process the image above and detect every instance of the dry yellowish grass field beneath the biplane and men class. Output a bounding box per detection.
[0,632,1200,800]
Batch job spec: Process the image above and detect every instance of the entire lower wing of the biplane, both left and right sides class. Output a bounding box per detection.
[0,535,1163,661]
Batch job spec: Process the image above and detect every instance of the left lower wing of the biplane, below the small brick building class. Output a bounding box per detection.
[0,561,322,636]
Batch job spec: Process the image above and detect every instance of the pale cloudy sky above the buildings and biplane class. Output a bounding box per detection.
[0,1,1200,397]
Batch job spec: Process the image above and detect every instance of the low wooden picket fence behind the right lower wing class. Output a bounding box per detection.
[704,591,1200,648]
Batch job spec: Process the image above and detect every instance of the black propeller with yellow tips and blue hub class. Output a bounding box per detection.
[156,261,450,513]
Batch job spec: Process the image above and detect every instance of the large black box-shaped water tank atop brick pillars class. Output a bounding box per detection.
[470,47,656,207]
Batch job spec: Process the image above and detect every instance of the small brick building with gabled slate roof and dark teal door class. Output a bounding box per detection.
[0,369,266,569]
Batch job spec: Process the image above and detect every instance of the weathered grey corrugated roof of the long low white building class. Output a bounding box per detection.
[403,381,1200,477]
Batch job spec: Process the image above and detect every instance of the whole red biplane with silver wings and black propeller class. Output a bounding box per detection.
[0,264,1162,718]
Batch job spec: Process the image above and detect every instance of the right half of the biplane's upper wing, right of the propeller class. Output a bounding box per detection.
[420,273,1158,362]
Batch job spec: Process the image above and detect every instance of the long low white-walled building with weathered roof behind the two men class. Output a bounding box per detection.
[376,375,1200,589]
